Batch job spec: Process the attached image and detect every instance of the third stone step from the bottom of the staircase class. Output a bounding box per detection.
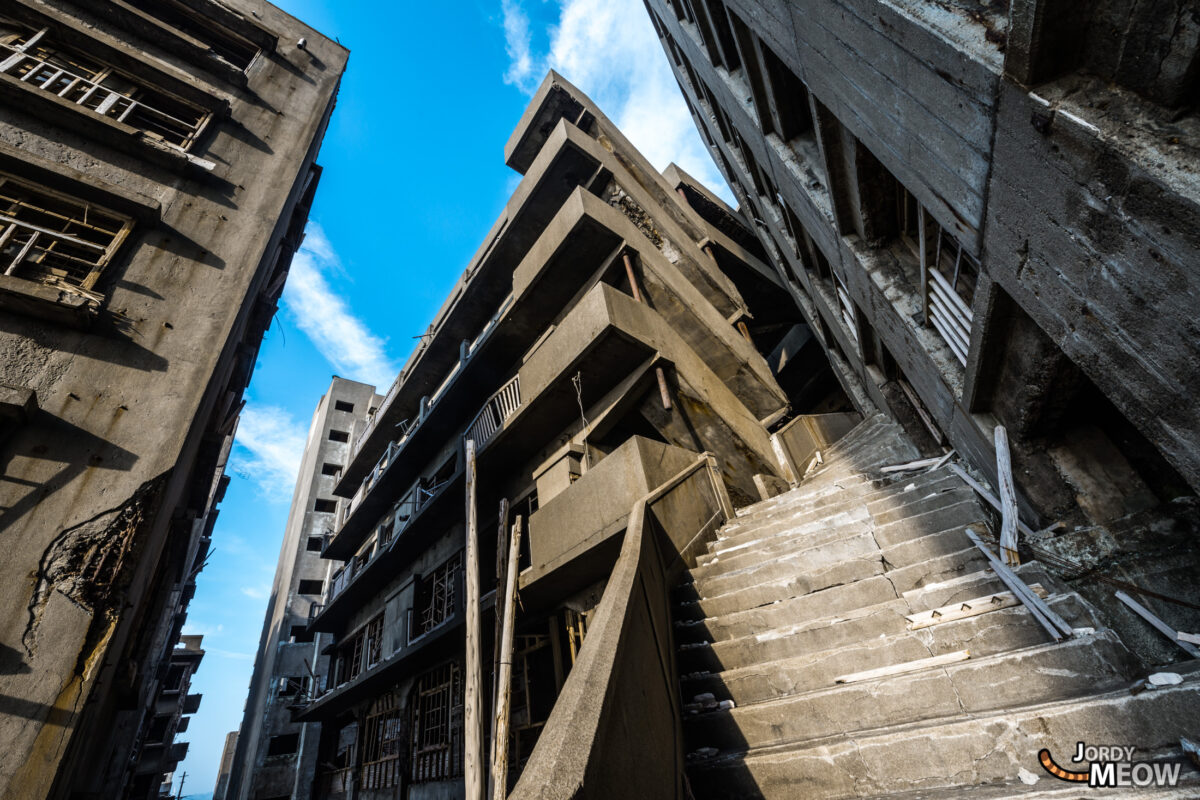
[680,595,1099,706]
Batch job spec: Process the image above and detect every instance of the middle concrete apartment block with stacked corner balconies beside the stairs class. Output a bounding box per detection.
[276,73,848,798]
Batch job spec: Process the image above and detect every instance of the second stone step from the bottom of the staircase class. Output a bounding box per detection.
[684,631,1134,752]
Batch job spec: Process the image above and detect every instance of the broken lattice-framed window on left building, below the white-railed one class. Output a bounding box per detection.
[0,173,133,296]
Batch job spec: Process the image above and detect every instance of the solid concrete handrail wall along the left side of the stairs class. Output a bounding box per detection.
[509,452,733,800]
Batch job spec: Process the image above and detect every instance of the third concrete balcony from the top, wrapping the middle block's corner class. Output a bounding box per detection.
[324,188,786,560]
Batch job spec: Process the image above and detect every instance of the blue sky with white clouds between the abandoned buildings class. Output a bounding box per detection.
[180,0,728,798]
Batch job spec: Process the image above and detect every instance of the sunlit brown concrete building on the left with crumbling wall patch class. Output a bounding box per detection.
[0,0,347,800]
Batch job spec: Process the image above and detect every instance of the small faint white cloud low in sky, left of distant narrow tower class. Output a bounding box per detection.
[230,404,306,503]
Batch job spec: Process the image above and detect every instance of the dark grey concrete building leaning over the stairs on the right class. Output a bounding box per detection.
[646,0,1200,638]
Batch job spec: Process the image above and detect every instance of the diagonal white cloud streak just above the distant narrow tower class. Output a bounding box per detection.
[283,222,397,386]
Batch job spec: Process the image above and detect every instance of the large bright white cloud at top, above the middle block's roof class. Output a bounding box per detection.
[502,0,736,205]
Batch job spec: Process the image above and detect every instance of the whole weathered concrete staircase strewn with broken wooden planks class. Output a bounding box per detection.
[674,416,1200,800]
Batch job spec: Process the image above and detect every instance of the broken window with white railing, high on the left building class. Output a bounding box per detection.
[0,20,212,150]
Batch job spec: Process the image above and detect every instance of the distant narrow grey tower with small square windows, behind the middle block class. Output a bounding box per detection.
[224,377,382,800]
